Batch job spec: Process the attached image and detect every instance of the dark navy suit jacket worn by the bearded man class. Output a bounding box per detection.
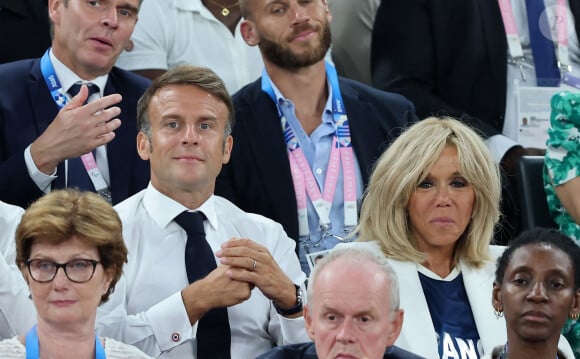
[215,78,416,243]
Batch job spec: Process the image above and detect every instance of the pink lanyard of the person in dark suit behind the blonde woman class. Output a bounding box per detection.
[498,0,572,81]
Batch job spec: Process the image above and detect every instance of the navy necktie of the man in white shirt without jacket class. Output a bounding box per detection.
[175,211,231,359]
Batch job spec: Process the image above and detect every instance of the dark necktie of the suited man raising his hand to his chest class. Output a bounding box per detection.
[52,82,99,191]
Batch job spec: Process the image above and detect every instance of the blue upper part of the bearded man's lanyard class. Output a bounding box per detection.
[262,61,352,147]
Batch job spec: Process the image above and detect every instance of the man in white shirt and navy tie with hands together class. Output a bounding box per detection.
[97,66,308,359]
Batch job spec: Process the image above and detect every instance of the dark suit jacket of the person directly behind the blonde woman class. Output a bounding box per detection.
[371,0,580,136]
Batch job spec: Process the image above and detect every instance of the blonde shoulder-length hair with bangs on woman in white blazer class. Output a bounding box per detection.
[355,117,501,267]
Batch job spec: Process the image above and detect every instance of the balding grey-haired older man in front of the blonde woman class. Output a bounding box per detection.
[258,246,422,359]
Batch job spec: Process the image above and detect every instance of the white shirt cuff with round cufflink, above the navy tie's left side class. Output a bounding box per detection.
[146,292,197,351]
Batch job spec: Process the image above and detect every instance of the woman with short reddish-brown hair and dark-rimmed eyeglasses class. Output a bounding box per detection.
[0,190,149,359]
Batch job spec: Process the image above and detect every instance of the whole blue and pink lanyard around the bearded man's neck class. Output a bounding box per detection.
[262,62,358,237]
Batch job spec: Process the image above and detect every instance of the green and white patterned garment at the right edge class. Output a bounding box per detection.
[544,91,580,359]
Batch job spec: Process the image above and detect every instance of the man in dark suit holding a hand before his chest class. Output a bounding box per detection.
[0,0,149,207]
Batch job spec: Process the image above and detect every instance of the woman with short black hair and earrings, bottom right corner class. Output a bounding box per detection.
[484,228,580,359]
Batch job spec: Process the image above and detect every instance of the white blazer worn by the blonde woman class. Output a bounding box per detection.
[341,241,507,358]
